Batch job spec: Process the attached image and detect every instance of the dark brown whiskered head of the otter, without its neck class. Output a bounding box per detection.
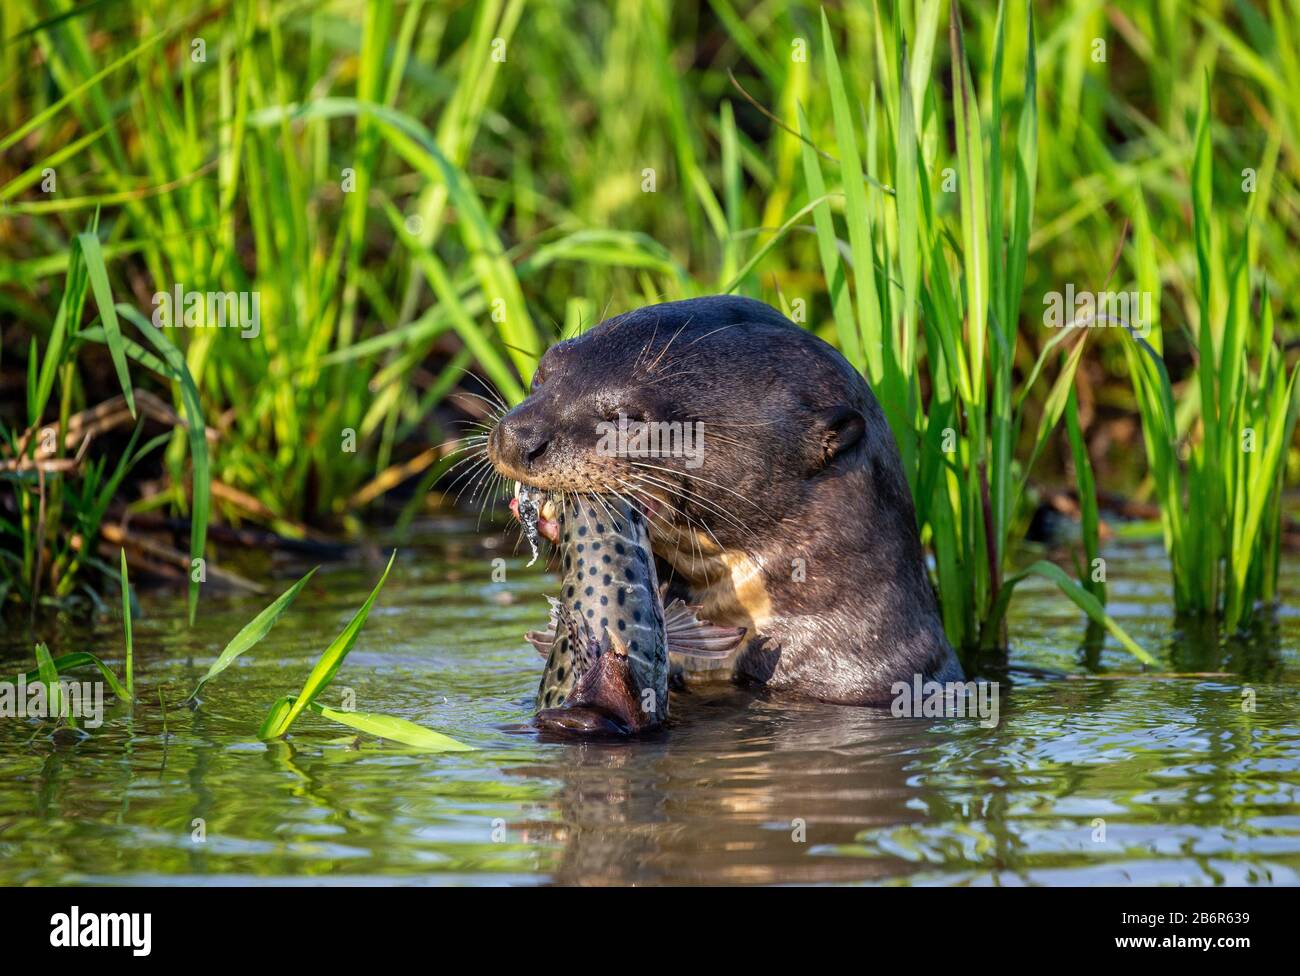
[488,296,884,577]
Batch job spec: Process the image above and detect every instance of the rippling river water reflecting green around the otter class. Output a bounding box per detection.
[0,526,1300,885]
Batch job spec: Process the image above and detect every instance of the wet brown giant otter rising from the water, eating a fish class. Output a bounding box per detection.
[488,295,961,704]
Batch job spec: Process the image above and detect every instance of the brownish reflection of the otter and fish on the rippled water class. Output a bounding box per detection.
[511,689,924,884]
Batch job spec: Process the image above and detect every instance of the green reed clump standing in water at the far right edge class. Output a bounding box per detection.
[1125,79,1297,630]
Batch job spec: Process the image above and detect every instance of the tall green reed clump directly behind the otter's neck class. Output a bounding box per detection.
[802,0,1151,660]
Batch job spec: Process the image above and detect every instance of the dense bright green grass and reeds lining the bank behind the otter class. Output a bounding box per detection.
[0,0,1300,656]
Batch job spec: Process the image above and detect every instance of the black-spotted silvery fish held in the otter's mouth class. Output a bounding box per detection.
[511,485,745,734]
